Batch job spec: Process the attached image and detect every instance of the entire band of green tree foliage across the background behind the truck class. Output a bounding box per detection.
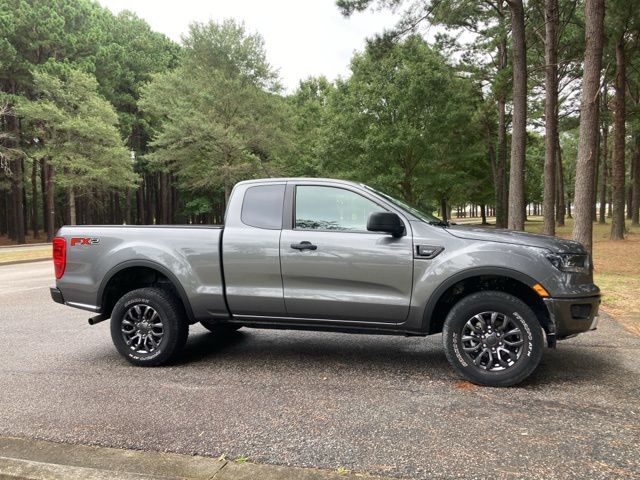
[0,0,640,232]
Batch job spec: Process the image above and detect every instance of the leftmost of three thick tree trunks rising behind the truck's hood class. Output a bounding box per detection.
[507,0,527,230]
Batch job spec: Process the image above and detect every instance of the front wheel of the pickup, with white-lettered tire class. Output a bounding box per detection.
[442,291,544,387]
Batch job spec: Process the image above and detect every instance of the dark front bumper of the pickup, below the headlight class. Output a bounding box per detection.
[544,295,600,340]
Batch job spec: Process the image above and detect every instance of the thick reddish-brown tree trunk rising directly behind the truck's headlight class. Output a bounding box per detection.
[573,0,604,252]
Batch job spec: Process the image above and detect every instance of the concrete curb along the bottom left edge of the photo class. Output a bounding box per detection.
[0,437,390,480]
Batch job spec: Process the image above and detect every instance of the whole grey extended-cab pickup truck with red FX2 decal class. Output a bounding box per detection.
[51,178,600,386]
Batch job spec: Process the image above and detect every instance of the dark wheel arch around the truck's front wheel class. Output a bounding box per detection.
[422,267,555,334]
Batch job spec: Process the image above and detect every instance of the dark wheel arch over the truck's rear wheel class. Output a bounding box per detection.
[97,260,196,324]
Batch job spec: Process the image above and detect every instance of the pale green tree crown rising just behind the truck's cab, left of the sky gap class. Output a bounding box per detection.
[140,21,284,201]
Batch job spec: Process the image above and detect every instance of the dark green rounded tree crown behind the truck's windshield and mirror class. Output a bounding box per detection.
[324,36,488,209]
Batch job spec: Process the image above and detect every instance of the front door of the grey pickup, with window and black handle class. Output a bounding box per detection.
[280,182,413,323]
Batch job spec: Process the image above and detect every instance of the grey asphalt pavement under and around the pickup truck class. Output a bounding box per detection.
[0,262,640,479]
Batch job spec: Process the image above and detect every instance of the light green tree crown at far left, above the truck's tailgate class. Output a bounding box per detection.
[17,68,135,191]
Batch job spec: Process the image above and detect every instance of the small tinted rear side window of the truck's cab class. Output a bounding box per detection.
[240,185,285,230]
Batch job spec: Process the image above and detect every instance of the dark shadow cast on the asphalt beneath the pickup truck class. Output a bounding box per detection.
[174,329,621,388]
